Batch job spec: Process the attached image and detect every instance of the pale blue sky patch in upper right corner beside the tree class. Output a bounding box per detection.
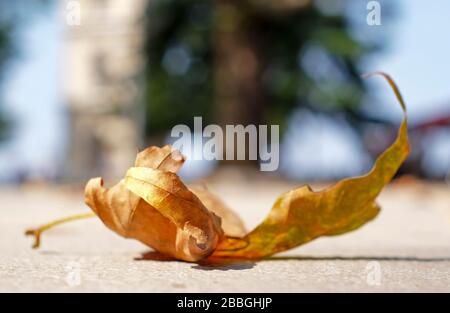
[366,0,450,121]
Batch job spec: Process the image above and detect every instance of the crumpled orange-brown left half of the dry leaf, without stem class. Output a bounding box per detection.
[85,146,237,262]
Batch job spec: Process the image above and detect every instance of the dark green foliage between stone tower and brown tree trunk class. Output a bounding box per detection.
[146,0,214,133]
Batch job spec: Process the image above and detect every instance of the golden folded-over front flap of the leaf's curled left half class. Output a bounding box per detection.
[125,167,223,261]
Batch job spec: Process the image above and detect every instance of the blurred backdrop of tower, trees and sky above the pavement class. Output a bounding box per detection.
[0,0,450,185]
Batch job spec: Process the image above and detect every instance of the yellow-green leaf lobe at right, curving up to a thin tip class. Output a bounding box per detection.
[213,73,409,259]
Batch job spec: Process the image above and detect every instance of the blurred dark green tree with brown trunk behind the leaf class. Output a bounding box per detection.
[146,0,384,134]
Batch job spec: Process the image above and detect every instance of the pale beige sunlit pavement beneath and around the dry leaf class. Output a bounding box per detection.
[0,173,450,292]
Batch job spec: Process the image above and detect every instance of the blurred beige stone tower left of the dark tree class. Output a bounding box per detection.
[62,0,148,181]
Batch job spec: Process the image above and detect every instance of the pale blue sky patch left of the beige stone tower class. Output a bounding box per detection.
[0,6,66,179]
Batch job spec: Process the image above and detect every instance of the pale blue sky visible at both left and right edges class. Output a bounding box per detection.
[0,0,450,180]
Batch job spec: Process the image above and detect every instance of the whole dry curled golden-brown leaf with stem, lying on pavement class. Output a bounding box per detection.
[27,73,410,262]
